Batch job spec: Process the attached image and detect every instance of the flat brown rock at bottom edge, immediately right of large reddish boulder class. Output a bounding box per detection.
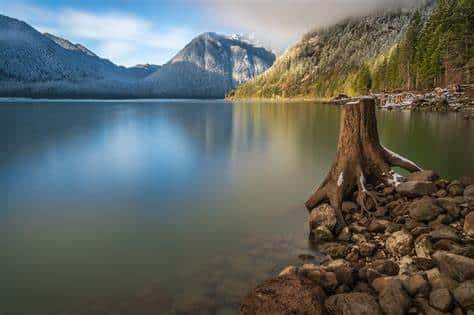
[324,292,383,315]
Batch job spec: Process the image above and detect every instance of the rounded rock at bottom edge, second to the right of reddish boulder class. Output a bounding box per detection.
[379,281,410,315]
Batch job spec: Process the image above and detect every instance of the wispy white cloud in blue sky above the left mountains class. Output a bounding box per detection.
[0,3,195,66]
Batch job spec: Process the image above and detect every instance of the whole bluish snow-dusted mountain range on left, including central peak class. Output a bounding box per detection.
[0,15,275,98]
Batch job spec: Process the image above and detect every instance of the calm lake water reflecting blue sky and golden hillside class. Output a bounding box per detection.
[0,100,474,315]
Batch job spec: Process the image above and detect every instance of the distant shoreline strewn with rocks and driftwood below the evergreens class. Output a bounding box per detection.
[330,84,474,119]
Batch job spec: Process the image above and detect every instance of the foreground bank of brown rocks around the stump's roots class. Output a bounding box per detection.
[240,171,474,315]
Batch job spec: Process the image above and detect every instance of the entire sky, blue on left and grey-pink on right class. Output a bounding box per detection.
[0,0,423,66]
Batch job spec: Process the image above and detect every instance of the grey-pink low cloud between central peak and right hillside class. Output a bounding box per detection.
[206,0,423,48]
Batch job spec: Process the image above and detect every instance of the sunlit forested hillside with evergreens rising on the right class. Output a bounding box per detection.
[229,0,474,98]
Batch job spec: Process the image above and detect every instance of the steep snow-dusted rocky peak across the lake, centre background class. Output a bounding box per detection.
[146,33,275,97]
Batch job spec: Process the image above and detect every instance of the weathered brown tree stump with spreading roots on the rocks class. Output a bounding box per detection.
[305,97,421,229]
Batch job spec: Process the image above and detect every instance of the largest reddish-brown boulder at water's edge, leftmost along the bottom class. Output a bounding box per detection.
[239,275,326,315]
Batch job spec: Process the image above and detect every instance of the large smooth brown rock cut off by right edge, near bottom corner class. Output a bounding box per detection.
[433,251,474,282]
